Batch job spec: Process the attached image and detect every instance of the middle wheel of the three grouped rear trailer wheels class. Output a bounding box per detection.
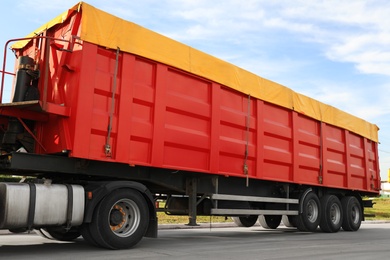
[320,195,343,233]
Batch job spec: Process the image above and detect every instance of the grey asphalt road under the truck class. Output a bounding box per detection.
[0,223,390,260]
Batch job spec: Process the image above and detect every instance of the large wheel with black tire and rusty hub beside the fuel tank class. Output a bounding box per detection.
[88,189,149,249]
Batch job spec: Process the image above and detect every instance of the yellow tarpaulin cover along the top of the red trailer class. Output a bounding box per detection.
[12,2,379,142]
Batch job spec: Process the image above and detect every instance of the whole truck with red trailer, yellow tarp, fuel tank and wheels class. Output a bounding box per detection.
[0,2,380,249]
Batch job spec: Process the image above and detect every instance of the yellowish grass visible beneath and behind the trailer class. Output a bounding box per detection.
[157,198,390,224]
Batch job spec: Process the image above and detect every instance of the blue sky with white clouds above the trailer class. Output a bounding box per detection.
[0,0,390,180]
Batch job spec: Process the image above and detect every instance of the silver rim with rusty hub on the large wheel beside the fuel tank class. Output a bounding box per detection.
[108,199,141,237]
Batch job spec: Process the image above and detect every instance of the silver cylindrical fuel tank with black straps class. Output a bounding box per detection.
[0,183,85,229]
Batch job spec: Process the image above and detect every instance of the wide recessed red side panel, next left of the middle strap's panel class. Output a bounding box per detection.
[163,69,211,171]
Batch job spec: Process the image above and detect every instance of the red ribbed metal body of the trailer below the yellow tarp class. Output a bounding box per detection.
[7,6,380,193]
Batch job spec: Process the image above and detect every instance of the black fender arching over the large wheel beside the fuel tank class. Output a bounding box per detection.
[84,181,158,238]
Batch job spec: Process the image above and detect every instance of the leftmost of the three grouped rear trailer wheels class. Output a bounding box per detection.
[293,191,321,232]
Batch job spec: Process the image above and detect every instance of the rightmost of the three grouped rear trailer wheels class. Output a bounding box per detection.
[341,196,363,231]
